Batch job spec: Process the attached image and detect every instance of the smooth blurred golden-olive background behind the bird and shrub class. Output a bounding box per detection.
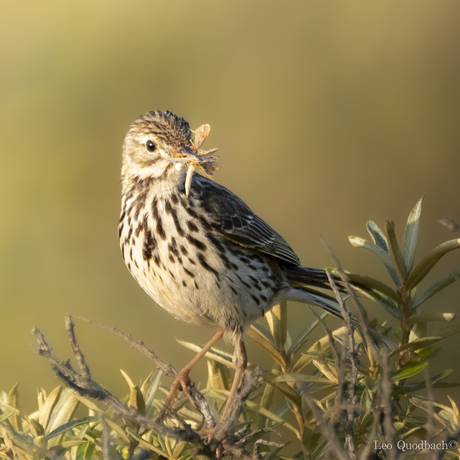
[0,0,460,412]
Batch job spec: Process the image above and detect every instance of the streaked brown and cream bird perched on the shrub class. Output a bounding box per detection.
[118,110,388,430]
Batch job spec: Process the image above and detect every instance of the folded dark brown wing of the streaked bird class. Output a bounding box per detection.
[192,175,300,265]
